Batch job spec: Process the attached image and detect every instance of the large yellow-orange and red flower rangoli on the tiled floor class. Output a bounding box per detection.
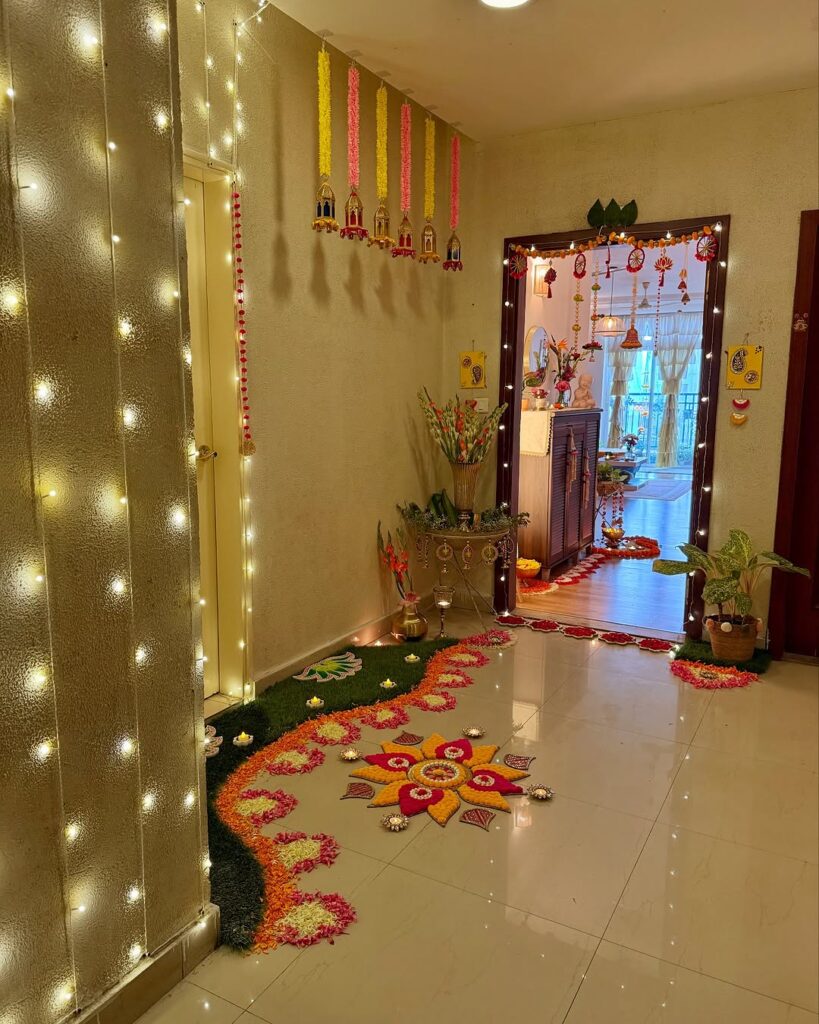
[352,733,527,825]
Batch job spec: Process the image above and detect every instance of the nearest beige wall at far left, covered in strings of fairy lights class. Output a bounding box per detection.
[0,0,207,1024]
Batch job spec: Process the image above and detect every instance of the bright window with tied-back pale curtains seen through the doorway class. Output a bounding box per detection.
[603,312,702,470]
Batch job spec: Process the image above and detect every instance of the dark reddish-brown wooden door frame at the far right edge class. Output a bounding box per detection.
[768,210,819,658]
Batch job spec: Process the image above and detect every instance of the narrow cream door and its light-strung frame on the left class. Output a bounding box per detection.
[183,160,252,718]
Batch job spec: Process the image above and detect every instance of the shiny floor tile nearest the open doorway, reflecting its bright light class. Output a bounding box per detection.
[546,659,712,743]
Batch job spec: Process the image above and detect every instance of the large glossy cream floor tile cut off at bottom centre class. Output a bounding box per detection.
[244,867,597,1024]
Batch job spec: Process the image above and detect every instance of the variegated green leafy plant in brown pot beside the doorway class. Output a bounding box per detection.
[651,529,810,662]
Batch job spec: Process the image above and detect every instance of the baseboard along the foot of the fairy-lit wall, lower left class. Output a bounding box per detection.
[73,903,219,1024]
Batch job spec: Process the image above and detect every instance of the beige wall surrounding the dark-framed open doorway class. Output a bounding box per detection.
[445,90,819,606]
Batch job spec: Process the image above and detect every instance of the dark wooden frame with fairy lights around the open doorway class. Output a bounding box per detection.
[494,214,731,639]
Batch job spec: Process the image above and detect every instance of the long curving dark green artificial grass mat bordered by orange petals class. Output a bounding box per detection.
[206,639,457,949]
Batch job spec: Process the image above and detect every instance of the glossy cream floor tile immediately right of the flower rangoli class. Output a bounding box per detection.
[501,705,686,818]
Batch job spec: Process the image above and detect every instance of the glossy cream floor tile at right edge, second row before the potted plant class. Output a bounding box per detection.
[659,748,819,864]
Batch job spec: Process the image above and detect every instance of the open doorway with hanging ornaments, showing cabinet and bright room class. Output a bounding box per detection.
[495,217,728,637]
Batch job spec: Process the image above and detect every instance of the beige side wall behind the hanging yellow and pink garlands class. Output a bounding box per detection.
[179,6,454,678]
